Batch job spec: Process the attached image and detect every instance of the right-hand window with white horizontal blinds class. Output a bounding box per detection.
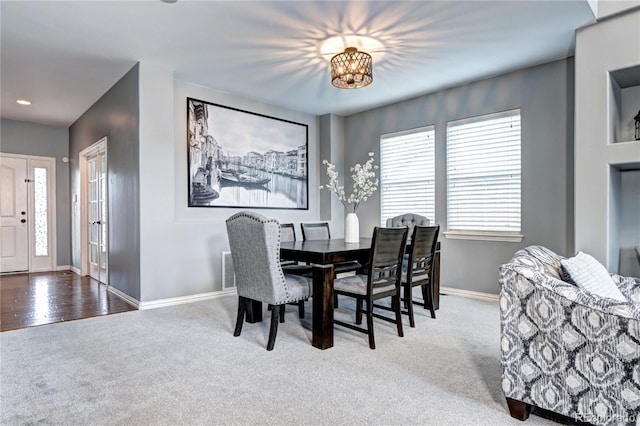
[445,109,522,241]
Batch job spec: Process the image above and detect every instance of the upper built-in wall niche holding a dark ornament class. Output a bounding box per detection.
[609,65,640,143]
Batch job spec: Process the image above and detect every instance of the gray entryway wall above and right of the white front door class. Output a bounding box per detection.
[0,118,71,266]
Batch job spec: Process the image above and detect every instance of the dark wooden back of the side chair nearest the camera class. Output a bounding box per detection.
[367,226,407,294]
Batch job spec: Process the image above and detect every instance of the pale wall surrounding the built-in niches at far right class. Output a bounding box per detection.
[575,9,640,272]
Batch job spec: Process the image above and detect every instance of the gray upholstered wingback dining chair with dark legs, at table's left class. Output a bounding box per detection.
[226,211,311,351]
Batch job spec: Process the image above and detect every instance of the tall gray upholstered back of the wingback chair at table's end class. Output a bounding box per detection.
[226,211,287,305]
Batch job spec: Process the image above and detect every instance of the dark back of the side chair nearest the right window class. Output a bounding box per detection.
[407,225,440,283]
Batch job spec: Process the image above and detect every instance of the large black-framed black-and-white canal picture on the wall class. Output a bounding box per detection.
[187,98,308,209]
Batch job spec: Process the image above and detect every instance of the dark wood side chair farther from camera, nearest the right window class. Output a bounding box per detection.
[401,225,440,327]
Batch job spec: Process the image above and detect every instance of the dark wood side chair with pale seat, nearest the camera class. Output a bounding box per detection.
[333,226,407,349]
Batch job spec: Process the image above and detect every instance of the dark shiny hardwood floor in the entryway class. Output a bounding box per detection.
[0,271,136,331]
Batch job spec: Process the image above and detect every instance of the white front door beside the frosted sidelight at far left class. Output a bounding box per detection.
[0,156,29,272]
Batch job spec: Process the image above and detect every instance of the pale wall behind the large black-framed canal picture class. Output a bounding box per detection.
[140,63,320,306]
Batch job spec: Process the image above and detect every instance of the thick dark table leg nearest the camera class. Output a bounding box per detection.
[311,265,334,349]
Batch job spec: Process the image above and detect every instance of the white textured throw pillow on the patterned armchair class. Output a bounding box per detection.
[560,251,627,302]
